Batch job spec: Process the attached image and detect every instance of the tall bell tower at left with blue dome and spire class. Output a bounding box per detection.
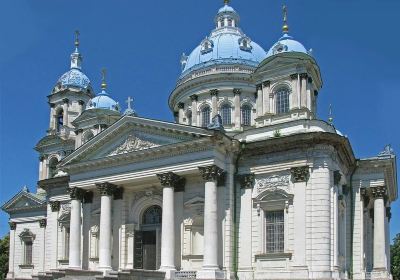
[35,31,93,180]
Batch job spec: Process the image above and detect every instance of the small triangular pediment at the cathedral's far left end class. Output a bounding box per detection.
[2,190,45,213]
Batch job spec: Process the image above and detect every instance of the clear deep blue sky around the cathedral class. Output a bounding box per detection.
[0,0,400,241]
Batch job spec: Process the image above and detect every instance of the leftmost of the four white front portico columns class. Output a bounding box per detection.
[69,188,83,269]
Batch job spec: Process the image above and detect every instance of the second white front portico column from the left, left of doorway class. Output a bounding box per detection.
[96,182,116,270]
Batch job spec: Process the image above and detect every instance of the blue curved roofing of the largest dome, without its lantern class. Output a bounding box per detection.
[183,28,266,74]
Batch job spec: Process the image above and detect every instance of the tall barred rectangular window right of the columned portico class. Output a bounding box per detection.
[265,210,285,253]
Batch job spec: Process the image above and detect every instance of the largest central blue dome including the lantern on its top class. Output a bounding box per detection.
[182,2,266,75]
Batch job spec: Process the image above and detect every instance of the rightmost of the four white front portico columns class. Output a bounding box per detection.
[199,165,224,279]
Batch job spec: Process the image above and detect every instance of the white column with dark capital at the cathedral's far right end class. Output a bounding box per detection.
[371,187,387,271]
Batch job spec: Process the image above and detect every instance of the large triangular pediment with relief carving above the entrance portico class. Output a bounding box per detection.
[61,116,213,166]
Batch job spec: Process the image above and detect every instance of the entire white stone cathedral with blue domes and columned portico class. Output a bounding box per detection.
[2,0,398,280]
